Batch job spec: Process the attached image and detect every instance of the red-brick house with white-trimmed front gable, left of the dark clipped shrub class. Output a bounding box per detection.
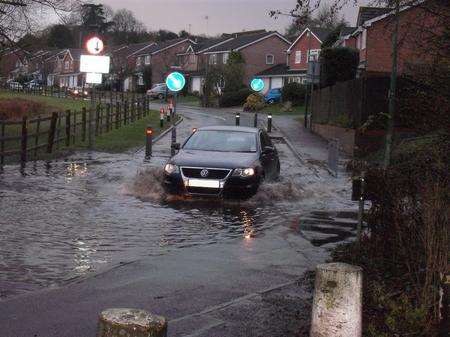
[257,27,332,91]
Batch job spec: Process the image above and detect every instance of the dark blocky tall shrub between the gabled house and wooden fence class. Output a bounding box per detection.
[320,47,359,87]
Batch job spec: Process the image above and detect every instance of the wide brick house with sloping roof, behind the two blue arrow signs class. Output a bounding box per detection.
[179,30,290,92]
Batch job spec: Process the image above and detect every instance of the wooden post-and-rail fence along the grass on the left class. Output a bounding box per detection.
[0,96,150,168]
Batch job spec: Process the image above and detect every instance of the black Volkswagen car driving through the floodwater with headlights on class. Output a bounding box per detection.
[163,126,280,198]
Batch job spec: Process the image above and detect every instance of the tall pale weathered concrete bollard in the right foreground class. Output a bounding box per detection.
[310,263,362,337]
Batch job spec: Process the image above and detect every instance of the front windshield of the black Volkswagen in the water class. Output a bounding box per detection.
[183,130,256,152]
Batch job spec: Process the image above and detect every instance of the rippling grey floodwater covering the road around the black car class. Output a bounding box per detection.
[0,109,356,300]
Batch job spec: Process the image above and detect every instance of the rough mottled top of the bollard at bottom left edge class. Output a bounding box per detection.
[97,308,167,337]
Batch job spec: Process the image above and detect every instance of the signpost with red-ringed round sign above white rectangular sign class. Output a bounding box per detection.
[80,36,111,149]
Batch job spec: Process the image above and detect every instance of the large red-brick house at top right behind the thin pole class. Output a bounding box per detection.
[352,1,443,74]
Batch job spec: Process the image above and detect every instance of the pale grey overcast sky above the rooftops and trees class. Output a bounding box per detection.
[98,0,364,35]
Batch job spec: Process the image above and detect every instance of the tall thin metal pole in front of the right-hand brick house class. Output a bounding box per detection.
[384,0,400,169]
